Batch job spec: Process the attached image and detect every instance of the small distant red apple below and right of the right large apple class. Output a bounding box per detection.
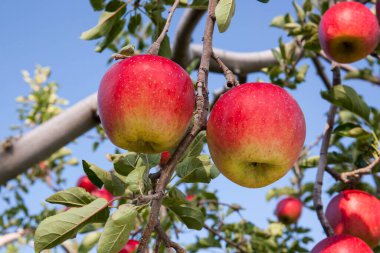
[275,197,302,225]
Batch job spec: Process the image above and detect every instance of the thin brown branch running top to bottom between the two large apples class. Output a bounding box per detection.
[137,0,217,253]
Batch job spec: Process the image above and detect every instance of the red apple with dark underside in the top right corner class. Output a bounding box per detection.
[319,2,379,63]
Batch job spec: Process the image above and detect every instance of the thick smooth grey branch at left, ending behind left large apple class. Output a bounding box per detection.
[0,94,99,184]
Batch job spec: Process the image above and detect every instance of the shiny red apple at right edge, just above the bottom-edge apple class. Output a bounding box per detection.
[326,190,380,248]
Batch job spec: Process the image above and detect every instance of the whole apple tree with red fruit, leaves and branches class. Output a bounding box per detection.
[0,0,380,253]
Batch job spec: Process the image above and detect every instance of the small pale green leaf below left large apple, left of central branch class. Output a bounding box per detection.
[126,166,151,194]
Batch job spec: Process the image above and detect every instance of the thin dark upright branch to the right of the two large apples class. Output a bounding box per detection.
[313,62,341,237]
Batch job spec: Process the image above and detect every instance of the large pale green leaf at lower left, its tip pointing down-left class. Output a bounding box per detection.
[34,199,109,253]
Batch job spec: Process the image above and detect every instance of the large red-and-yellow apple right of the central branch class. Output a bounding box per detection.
[207,83,306,188]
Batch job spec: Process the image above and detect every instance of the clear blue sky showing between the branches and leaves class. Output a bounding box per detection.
[0,0,379,252]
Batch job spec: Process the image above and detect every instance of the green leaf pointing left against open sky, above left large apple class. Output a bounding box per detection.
[80,4,126,40]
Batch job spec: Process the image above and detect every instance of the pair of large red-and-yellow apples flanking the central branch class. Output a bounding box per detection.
[98,55,306,188]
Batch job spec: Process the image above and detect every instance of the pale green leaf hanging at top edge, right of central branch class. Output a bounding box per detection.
[215,0,235,33]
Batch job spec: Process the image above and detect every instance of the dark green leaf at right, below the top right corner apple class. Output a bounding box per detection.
[321,85,370,121]
